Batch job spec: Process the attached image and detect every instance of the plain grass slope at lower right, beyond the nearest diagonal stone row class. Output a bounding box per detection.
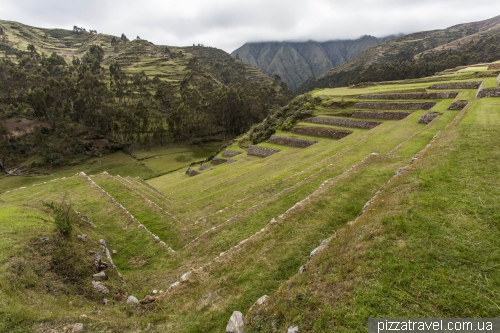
[251,93,500,332]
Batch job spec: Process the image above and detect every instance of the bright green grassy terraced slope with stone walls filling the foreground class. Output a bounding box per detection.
[0,63,500,332]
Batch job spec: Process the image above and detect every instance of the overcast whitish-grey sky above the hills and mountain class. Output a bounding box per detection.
[0,0,500,52]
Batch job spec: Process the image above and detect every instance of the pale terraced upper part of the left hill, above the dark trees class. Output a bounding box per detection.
[0,20,273,85]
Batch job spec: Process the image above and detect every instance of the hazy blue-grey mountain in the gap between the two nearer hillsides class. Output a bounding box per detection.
[231,36,396,90]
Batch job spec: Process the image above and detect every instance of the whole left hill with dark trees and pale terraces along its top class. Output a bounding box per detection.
[0,21,290,170]
